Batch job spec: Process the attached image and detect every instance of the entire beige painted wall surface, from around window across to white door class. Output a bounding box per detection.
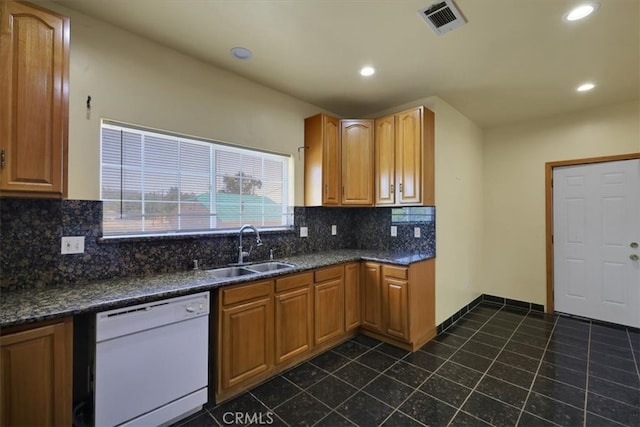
[48,5,640,323]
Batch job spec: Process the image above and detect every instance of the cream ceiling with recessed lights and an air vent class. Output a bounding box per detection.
[52,0,640,128]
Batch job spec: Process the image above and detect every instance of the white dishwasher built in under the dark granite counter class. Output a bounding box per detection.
[94,292,210,427]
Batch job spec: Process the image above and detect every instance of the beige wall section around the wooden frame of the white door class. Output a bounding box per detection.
[482,102,640,304]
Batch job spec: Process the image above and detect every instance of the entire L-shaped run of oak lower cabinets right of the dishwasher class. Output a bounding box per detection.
[216,259,436,403]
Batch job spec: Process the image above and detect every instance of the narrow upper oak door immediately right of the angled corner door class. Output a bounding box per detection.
[375,115,396,205]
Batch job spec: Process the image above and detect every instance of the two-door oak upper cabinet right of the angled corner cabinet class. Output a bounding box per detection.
[375,107,435,206]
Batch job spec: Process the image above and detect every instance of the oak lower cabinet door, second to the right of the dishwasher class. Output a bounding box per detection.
[275,286,313,364]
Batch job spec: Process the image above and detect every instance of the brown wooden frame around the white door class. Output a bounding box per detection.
[544,153,640,314]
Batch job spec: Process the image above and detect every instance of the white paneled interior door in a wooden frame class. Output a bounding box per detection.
[553,159,640,327]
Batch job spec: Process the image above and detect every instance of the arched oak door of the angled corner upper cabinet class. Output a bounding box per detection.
[340,120,374,206]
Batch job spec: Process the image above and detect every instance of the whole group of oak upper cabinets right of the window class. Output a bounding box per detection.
[304,106,435,206]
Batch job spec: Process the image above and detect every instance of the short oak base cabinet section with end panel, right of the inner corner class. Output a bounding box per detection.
[362,259,436,351]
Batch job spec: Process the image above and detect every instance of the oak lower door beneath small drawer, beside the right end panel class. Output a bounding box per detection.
[382,277,409,340]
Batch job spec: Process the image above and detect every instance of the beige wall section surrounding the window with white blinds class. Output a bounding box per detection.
[56,5,320,205]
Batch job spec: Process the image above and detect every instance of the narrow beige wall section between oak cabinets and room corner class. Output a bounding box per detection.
[374,97,483,323]
